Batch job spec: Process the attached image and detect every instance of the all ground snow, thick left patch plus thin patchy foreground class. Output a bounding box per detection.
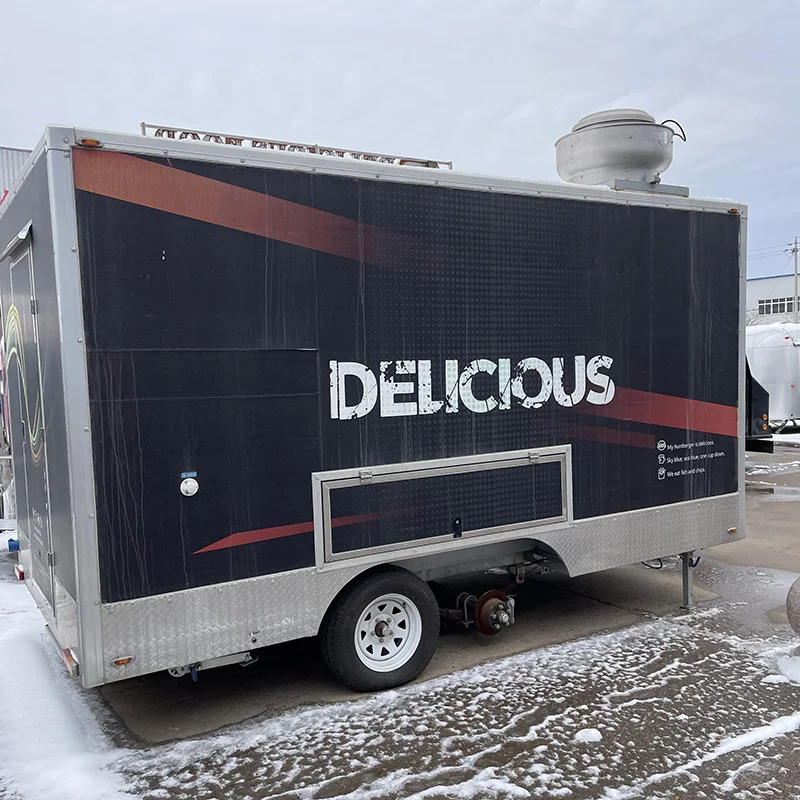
[0,561,800,800]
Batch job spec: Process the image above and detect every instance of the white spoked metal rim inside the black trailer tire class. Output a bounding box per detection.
[355,594,422,672]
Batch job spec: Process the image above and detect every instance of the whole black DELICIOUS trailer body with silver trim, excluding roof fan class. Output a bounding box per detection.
[0,127,746,688]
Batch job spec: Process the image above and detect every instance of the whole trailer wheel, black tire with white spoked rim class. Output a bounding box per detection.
[319,569,439,692]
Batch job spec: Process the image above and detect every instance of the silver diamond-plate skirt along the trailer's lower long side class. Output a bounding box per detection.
[97,494,744,682]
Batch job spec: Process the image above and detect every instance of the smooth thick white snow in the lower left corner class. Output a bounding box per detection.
[0,560,131,800]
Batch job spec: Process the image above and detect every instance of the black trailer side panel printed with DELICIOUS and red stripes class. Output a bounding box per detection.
[70,151,739,601]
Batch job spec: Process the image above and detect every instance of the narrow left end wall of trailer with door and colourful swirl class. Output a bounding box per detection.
[0,156,76,602]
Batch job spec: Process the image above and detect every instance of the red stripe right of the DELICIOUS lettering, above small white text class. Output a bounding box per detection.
[588,387,739,436]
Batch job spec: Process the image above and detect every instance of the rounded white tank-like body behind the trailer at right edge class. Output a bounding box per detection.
[746,322,800,422]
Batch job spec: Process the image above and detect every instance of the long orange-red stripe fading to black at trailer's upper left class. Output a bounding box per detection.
[73,148,418,268]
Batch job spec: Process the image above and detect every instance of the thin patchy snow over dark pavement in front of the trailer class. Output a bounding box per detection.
[116,615,800,800]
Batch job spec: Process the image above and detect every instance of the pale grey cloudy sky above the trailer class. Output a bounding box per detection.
[0,0,800,275]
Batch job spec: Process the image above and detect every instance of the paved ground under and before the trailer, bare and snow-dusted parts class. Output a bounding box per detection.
[20,447,800,800]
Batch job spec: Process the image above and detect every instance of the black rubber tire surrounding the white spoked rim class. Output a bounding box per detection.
[319,567,439,692]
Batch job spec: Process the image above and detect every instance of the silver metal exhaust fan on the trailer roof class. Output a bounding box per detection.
[556,108,685,188]
